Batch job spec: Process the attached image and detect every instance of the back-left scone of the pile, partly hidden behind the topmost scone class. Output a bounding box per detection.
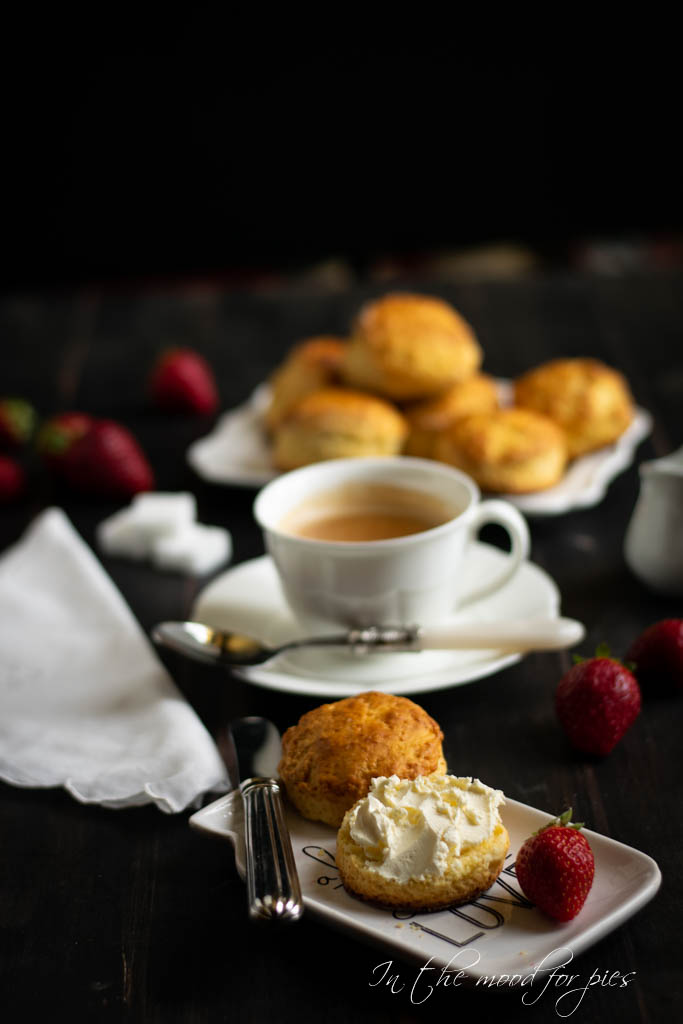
[265,335,346,431]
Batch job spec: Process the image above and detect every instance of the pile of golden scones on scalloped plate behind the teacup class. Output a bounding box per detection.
[265,292,634,494]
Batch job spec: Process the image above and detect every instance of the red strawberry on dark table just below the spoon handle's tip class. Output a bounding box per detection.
[555,648,641,755]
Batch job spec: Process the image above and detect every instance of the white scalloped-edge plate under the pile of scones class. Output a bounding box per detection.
[186,379,652,516]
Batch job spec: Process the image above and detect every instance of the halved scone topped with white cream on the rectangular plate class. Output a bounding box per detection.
[336,775,510,910]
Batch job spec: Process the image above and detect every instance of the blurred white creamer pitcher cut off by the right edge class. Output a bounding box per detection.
[624,447,683,594]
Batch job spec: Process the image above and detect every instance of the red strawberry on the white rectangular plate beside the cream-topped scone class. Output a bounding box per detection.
[515,808,595,921]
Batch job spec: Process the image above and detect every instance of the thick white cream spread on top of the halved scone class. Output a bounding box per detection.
[350,774,505,882]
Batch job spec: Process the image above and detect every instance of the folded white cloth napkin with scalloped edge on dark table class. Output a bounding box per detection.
[0,508,228,812]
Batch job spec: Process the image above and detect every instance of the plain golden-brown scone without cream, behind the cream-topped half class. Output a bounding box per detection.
[280,690,445,827]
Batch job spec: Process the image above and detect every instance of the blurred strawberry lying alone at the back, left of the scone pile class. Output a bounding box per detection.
[150,348,218,414]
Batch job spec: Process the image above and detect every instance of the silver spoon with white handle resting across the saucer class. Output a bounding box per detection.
[152,618,586,668]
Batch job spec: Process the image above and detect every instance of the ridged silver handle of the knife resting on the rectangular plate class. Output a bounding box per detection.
[240,777,303,921]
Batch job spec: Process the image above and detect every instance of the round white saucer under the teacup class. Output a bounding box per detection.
[191,542,560,697]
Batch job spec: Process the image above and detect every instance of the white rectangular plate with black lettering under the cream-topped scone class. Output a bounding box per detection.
[189,791,661,980]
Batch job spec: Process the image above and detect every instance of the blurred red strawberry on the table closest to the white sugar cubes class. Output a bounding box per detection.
[61,420,155,498]
